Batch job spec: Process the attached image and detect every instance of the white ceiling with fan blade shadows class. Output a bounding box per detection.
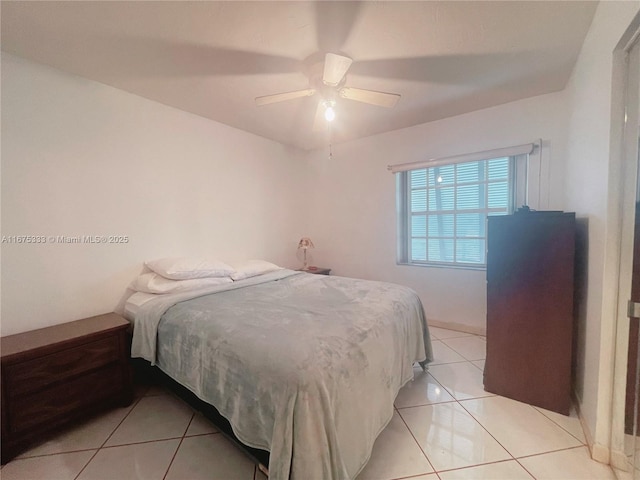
[1,1,596,149]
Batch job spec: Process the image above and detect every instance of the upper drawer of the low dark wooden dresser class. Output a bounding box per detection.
[3,335,120,397]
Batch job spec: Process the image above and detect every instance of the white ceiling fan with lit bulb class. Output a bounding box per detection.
[255,53,400,131]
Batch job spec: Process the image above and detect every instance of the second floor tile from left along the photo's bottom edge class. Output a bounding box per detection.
[78,437,179,480]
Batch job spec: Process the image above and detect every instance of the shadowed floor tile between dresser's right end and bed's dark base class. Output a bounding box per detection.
[106,395,193,446]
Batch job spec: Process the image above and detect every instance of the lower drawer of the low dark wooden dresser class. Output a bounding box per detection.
[9,364,126,433]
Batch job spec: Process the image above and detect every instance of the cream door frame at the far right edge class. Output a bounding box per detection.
[601,14,640,471]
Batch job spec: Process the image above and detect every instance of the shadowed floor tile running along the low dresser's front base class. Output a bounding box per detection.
[19,405,133,458]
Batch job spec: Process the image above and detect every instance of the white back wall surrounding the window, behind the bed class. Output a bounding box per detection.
[307,92,567,333]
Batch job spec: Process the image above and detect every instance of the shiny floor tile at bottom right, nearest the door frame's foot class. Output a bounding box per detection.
[519,447,616,480]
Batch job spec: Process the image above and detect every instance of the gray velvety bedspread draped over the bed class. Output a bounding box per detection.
[132,270,432,480]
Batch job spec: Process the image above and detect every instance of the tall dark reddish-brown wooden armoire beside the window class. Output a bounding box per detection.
[484,211,575,415]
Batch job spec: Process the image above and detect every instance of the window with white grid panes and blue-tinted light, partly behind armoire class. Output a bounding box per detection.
[397,155,526,268]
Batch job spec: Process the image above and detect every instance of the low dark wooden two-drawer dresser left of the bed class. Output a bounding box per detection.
[0,313,133,464]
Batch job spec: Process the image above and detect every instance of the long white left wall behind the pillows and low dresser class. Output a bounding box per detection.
[1,53,306,335]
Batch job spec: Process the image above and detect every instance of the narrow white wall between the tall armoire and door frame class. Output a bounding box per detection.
[565,2,640,461]
